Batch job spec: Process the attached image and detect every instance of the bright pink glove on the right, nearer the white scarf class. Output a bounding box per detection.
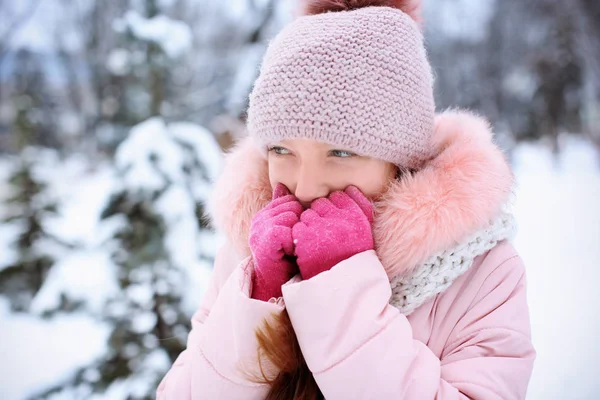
[292,186,374,279]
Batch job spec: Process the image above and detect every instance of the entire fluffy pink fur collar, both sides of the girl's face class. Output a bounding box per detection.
[209,110,514,279]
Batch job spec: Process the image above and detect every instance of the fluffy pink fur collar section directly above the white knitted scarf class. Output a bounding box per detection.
[373,111,514,277]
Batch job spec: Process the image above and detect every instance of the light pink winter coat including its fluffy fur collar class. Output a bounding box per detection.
[157,112,535,400]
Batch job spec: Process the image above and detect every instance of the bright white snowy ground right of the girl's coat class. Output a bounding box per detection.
[514,137,600,399]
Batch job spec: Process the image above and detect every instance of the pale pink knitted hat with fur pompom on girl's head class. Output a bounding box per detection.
[248,0,435,169]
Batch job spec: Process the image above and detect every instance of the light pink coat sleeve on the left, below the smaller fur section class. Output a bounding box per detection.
[156,244,284,400]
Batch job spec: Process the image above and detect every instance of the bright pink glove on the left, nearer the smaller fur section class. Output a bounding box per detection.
[249,184,304,301]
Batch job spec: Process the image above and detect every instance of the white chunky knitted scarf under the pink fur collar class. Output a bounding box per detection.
[389,211,516,315]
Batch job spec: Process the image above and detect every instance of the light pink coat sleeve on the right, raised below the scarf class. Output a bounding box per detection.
[283,251,535,400]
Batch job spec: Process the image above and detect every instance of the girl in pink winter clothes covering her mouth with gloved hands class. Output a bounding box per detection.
[157,0,535,400]
